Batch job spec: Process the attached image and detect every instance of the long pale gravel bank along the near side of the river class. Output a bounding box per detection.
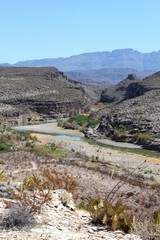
[32,133,160,182]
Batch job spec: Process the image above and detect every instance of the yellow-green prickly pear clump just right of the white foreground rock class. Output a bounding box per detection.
[79,199,133,232]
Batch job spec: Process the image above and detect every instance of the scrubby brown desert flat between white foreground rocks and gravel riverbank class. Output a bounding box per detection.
[0,130,160,240]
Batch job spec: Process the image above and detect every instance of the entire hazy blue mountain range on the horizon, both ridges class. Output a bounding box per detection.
[0,48,160,86]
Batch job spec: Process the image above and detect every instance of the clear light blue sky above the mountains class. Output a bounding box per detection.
[0,0,160,63]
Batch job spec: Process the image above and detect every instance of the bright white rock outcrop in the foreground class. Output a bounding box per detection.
[0,190,141,240]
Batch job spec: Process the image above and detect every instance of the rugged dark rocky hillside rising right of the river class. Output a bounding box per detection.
[89,72,160,150]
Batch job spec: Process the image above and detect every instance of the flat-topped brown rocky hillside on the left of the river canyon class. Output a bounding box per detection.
[0,67,96,124]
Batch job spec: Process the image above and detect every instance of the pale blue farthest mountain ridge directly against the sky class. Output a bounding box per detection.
[13,48,160,72]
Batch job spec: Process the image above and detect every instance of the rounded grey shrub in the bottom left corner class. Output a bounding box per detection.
[0,204,35,229]
